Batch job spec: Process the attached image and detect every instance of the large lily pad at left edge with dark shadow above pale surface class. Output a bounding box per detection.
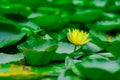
[0,20,25,48]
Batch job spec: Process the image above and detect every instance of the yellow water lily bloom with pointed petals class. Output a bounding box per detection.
[67,29,90,46]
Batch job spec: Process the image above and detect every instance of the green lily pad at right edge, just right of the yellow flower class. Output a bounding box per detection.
[91,30,120,58]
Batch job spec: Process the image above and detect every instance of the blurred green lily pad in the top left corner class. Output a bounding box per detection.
[0,4,31,17]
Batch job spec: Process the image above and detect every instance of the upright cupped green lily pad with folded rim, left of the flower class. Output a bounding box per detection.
[18,37,57,65]
